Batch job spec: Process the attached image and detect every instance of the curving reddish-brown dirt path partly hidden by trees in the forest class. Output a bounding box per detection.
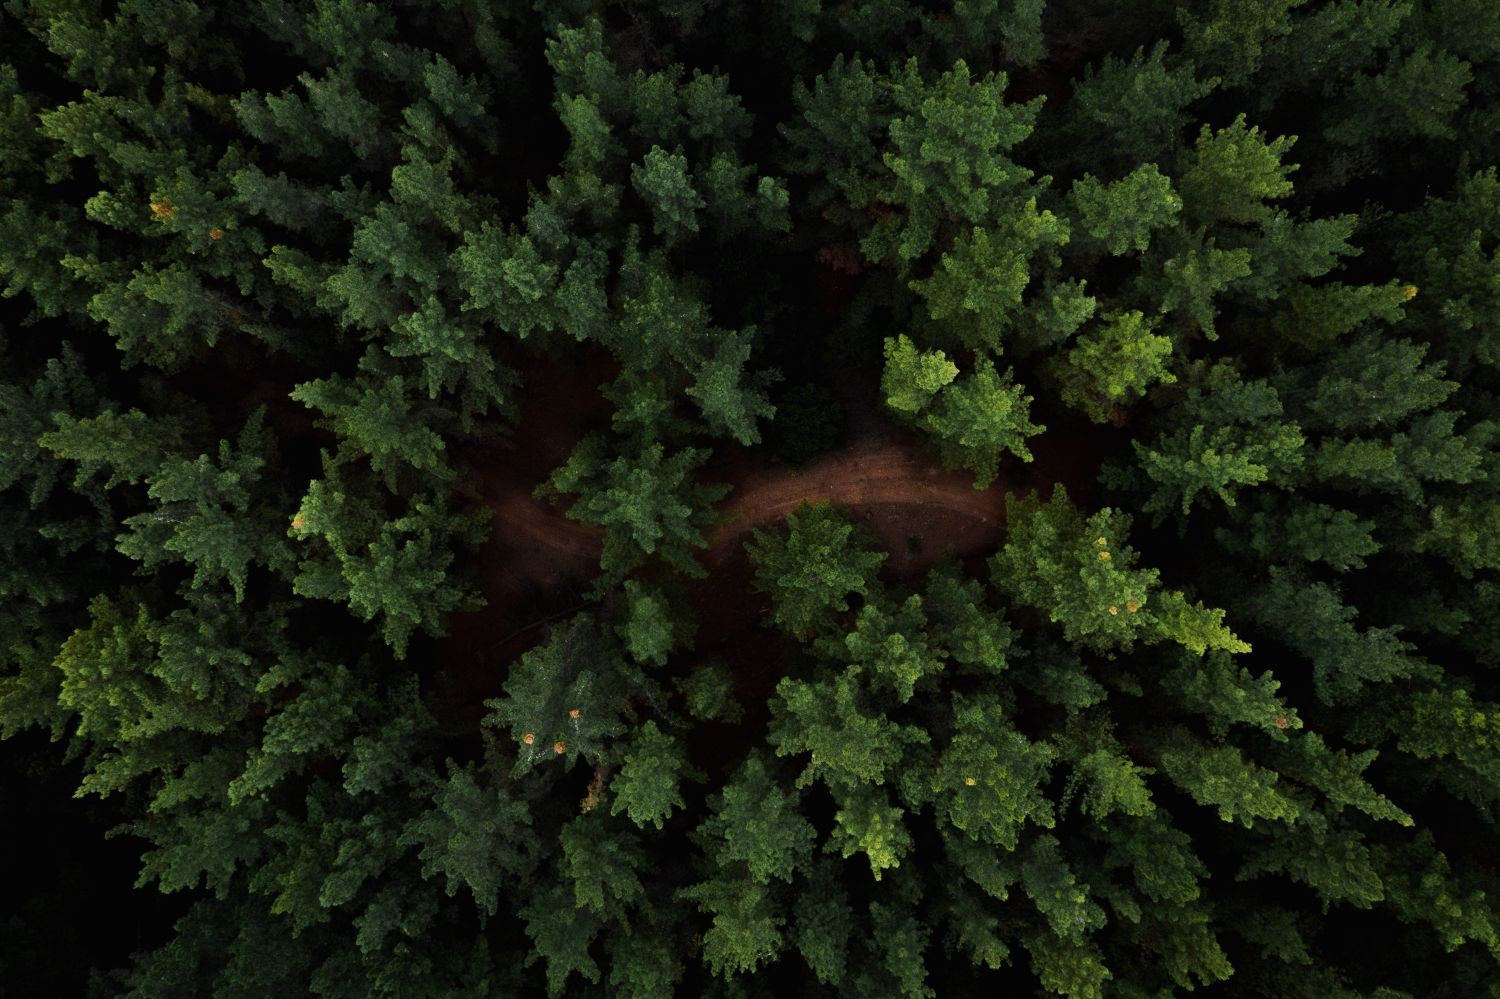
[438,441,1005,720]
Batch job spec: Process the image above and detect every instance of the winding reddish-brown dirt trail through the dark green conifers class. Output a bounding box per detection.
[438,420,1101,660]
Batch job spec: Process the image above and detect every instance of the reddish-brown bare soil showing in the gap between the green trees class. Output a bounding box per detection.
[441,342,1106,711]
